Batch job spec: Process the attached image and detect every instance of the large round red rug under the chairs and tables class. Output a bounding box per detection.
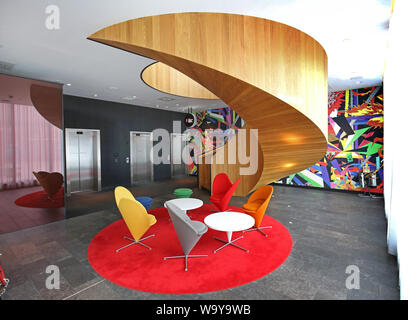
[88,204,292,294]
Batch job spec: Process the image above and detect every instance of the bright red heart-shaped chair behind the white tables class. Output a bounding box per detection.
[210,173,241,211]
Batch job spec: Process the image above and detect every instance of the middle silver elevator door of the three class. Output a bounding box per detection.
[130,132,153,185]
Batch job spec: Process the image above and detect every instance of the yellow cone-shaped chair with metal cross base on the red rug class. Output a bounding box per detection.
[115,187,156,252]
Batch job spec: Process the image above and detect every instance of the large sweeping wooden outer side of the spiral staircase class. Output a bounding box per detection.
[89,13,327,192]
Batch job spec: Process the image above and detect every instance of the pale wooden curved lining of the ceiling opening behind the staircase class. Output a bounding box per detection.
[142,62,218,99]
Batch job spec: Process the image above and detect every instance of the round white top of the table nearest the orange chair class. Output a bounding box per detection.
[204,211,255,232]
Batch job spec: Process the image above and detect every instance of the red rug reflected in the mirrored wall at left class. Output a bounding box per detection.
[14,188,64,208]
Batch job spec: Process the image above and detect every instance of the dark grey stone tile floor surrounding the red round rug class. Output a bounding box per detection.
[0,182,399,299]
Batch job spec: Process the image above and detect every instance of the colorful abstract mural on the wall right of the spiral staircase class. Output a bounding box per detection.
[279,86,384,193]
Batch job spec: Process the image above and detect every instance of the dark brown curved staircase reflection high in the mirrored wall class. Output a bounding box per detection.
[30,84,62,129]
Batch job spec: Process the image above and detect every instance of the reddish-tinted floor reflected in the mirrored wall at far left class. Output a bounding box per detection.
[0,187,64,234]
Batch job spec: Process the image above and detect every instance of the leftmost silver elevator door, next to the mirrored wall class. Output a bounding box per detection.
[65,129,100,194]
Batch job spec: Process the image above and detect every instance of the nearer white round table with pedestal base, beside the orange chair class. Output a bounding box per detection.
[204,211,255,253]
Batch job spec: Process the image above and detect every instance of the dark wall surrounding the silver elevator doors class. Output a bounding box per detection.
[63,95,185,189]
